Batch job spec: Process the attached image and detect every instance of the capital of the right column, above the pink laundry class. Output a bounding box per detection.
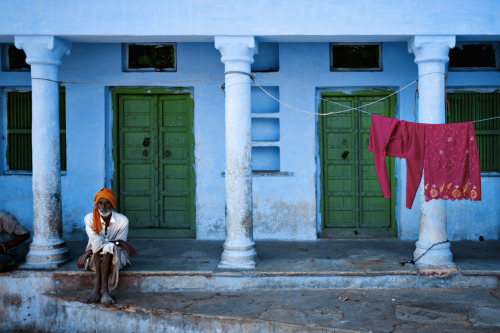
[408,36,456,64]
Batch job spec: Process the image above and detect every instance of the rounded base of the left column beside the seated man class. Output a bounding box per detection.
[19,242,71,270]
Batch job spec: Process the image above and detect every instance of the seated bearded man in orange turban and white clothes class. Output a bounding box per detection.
[77,188,135,305]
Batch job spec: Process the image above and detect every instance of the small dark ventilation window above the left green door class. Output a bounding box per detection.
[123,43,177,72]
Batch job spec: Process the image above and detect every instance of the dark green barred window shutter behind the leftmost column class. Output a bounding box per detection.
[6,88,66,171]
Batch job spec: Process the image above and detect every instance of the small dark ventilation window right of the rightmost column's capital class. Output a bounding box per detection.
[448,43,499,71]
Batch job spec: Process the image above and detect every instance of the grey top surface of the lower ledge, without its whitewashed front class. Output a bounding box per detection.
[53,289,500,333]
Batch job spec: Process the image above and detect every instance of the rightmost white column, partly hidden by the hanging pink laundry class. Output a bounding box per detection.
[408,36,456,275]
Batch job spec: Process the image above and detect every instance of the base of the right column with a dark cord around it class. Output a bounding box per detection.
[413,242,457,270]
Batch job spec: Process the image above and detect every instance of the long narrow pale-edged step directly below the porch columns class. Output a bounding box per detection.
[48,271,498,292]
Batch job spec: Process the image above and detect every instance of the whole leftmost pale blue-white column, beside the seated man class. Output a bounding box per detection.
[15,36,71,269]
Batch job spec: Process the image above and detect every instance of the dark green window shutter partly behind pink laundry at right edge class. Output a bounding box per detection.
[446,92,500,172]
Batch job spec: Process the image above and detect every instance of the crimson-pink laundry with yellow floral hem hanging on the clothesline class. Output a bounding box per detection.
[368,114,481,209]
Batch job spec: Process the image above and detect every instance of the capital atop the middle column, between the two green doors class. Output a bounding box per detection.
[215,36,257,65]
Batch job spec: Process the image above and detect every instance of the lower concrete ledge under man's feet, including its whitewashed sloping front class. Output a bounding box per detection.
[7,288,500,333]
